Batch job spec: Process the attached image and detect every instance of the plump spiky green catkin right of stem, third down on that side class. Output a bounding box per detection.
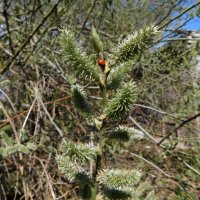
[105,82,137,120]
